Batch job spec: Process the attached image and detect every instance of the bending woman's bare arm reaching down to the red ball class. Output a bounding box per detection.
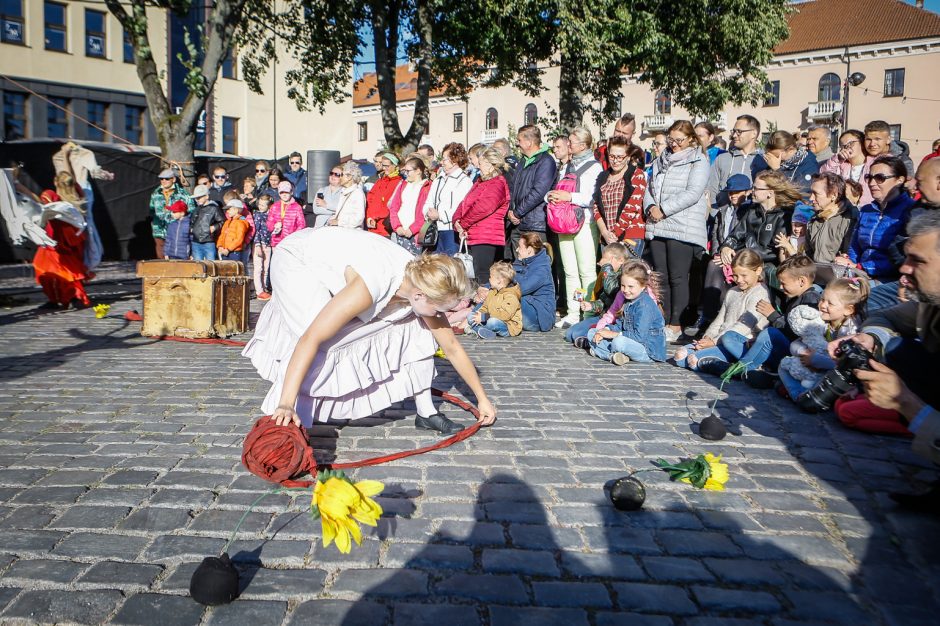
[271,268,373,426]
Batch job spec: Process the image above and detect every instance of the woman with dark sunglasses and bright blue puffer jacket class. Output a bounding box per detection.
[835,156,914,282]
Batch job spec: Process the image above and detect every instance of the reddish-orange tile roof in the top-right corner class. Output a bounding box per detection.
[774,0,940,54]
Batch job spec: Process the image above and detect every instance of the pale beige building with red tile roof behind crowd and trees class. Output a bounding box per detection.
[352,0,940,162]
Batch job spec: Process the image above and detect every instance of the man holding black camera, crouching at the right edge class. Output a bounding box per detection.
[829,211,940,512]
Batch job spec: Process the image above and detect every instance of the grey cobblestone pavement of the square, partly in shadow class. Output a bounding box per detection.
[0,272,940,626]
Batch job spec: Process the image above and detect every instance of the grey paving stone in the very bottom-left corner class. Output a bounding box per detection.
[3,589,121,624]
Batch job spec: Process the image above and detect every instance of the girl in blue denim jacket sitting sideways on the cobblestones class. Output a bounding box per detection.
[587,260,666,365]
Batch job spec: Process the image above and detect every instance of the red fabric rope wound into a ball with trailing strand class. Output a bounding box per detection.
[124,311,480,487]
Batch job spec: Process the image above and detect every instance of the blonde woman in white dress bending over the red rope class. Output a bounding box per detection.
[243,228,496,434]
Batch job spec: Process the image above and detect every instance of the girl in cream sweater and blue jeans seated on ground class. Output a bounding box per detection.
[674,248,770,373]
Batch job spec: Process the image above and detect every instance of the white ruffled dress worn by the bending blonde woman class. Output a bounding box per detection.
[242,227,437,426]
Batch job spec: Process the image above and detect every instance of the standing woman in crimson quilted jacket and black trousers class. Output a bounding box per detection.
[454,148,509,283]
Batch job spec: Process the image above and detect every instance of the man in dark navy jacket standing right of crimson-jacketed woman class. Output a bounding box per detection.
[505,125,555,258]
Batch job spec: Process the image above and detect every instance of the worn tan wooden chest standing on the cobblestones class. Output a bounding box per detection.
[137,261,250,337]
